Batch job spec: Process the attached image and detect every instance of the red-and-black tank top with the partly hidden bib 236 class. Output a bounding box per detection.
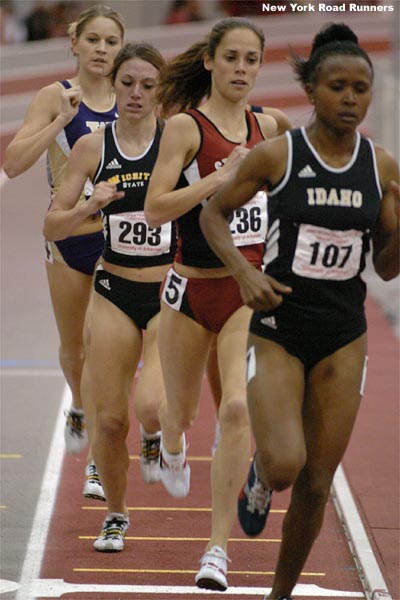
[175,109,267,269]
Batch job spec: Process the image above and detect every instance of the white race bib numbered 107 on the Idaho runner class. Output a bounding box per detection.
[292,224,362,281]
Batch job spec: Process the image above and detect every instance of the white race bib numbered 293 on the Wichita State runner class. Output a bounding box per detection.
[109,211,172,256]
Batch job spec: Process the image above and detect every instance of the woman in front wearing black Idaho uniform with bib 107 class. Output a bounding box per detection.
[200,24,399,600]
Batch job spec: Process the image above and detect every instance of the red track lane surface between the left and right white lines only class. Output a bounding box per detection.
[37,385,362,600]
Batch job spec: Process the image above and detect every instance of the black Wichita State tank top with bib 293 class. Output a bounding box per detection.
[94,121,176,268]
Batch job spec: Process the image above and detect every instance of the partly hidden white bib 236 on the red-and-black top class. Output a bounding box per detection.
[229,191,267,246]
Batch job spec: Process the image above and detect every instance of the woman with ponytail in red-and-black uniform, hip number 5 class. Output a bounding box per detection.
[145,19,277,590]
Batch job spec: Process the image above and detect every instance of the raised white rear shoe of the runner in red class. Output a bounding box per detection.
[160,434,190,498]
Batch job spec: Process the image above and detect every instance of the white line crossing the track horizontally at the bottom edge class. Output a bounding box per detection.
[27,579,364,598]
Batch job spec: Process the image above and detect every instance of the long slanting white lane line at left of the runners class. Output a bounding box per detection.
[16,385,72,600]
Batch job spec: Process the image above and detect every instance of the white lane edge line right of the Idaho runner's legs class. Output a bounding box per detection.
[332,465,392,600]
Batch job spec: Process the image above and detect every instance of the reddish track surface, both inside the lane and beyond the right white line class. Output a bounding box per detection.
[32,300,400,600]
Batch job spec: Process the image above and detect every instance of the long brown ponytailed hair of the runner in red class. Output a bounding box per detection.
[158,17,265,116]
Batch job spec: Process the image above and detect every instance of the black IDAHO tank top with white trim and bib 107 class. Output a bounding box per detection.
[264,127,382,319]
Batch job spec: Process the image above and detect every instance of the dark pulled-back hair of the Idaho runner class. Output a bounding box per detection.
[291,23,374,88]
